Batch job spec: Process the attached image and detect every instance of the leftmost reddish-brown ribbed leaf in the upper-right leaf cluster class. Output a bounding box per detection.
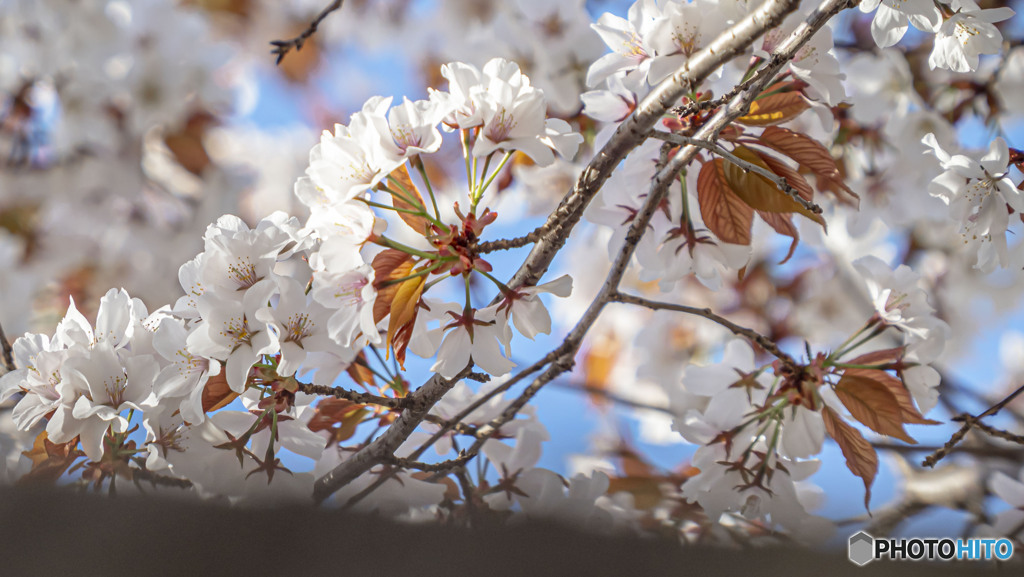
[697,158,754,245]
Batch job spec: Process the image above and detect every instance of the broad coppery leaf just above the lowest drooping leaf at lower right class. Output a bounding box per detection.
[836,370,918,444]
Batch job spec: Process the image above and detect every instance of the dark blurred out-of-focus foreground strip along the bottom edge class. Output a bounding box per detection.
[0,488,999,577]
